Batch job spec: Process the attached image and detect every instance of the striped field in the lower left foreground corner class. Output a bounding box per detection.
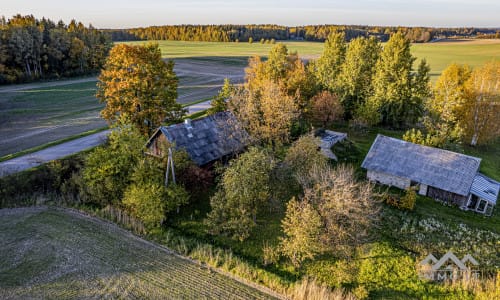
[0,207,278,299]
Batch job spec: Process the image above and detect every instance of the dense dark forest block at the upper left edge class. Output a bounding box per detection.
[0,15,112,84]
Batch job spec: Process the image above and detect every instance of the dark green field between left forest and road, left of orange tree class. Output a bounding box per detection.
[0,78,106,156]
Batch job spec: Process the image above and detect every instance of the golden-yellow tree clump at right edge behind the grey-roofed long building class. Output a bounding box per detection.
[425,62,500,146]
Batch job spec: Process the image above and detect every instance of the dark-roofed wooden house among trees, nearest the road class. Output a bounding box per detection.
[146,112,248,166]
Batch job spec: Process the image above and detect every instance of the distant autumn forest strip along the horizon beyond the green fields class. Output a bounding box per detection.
[105,25,496,43]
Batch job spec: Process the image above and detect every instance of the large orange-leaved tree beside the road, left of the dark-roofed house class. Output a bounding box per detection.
[97,44,185,134]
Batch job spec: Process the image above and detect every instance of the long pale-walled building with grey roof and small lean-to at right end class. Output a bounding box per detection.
[361,134,500,215]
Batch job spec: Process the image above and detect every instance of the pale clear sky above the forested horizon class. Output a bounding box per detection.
[0,0,500,28]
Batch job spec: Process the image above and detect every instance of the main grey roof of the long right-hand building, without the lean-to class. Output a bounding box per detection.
[361,134,481,196]
